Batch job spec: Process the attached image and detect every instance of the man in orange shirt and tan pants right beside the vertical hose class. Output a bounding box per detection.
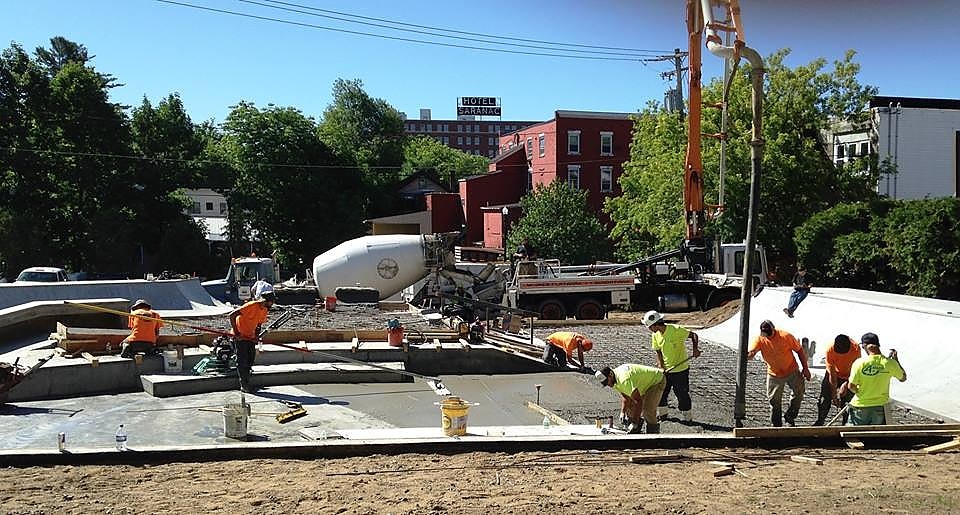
[747,320,810,427]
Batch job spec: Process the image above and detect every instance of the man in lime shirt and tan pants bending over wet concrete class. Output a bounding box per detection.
[594,363,666,434]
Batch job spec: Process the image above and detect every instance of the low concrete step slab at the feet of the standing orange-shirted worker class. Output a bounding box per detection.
[140,363,412,397]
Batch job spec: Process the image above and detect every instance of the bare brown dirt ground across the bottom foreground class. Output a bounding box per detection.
[0,449,960,514]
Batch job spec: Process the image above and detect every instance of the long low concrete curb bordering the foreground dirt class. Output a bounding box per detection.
[0,434,832,467]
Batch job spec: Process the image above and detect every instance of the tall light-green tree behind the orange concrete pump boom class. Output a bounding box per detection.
[606,50,880,259]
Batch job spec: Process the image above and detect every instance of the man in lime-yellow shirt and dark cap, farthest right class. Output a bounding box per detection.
[848,333,907,426]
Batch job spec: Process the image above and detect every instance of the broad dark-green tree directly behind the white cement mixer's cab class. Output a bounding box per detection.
[211,102,363,268]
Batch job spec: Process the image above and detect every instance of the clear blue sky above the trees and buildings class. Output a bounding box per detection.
[0,0,960,122]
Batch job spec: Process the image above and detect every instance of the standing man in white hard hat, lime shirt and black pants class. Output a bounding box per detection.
[643,311,700,422]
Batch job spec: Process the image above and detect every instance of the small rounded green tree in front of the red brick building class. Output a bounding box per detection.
[508,180,609,264]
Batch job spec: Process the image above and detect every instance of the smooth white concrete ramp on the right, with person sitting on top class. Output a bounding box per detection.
[698,287,960,420]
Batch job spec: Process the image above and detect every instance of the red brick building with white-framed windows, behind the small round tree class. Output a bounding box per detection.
[460,111,633,246]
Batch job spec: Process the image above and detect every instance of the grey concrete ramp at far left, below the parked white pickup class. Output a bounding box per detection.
[0,279,231,318]
